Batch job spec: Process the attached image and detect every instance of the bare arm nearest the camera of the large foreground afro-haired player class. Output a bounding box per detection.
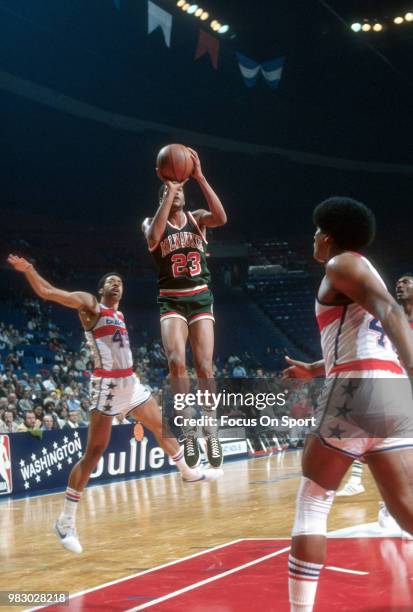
[326,253,413,377]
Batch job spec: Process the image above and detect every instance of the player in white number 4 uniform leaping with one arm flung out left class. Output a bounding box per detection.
[7,255,217,553]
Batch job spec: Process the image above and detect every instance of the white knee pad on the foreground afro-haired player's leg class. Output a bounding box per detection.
[292,476,334,536]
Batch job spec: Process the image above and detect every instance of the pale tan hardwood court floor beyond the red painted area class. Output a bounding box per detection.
[0,451,379,610]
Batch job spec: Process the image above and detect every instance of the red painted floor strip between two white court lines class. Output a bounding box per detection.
[38,540,288,612]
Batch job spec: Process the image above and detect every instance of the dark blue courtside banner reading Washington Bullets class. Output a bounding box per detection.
[0,425,247,497]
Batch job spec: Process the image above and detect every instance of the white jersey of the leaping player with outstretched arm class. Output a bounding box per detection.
[85,304,133,376]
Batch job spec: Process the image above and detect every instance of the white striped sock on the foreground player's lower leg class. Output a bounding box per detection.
[288,554,323,612]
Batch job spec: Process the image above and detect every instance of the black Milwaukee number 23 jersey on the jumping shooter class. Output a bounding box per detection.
[149,211,210,289]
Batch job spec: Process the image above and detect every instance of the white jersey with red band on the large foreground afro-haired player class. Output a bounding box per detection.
[316,254,404,376]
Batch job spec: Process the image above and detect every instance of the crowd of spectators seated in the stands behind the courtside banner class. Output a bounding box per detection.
[0,299,311,442]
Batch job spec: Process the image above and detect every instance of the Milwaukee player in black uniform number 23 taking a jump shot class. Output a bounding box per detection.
[142,149,227,468]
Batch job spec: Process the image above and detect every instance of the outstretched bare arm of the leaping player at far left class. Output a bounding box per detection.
[7,255,99,314]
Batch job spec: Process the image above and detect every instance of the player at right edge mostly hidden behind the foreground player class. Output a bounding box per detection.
[337,272,413,500]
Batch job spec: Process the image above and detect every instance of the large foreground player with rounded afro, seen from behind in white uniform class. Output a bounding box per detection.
[284,197,413,612]
